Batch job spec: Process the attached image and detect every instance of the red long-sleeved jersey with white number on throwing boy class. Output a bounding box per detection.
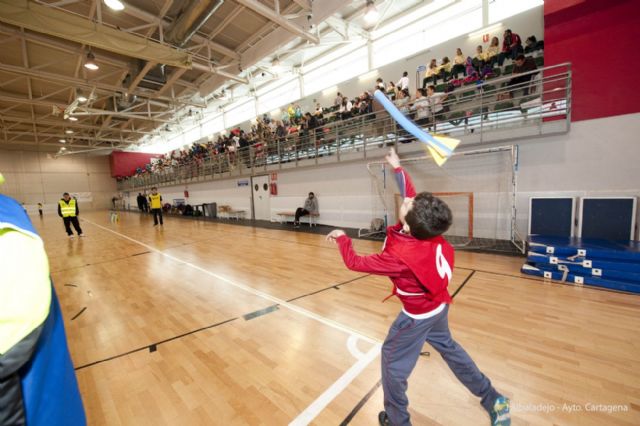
[336,168,454,315]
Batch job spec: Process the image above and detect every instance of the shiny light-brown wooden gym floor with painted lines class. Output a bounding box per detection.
[32,211,640,425]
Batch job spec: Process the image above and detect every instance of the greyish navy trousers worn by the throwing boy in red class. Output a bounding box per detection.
[382,305,501,426]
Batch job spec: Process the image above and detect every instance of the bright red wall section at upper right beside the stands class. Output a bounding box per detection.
[544,0,640,121]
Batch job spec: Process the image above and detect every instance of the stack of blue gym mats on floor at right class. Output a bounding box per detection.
[521,236,640,293]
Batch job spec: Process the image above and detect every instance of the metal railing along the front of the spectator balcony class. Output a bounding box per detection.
[118,63,571,190]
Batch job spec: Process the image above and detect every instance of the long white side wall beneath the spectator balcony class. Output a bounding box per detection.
[120,114,640,238]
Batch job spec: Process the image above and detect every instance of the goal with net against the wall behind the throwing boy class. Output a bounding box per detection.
[360,145,524,251]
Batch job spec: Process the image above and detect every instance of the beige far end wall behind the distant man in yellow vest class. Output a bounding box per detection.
[0,150,116,212]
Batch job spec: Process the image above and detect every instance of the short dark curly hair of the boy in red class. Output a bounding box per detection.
[404,192,453,240]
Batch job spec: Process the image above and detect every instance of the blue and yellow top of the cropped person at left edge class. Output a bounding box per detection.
[0,194,86,426]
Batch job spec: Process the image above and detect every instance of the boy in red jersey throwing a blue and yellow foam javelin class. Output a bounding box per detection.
[327,148,511,426]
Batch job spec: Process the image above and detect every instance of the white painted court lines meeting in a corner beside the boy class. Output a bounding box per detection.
[82,218,381,426]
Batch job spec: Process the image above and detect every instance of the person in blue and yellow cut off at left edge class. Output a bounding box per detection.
[0,174,86,426]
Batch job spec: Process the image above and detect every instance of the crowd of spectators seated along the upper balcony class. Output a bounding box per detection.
[117,29,544,182]
